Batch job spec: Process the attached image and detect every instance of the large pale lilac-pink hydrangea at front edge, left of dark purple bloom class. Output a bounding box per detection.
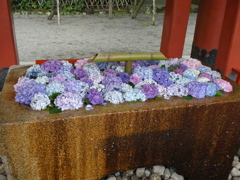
[54,92,83,111]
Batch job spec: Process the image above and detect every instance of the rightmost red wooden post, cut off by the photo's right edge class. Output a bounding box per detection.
[215,0,240,80]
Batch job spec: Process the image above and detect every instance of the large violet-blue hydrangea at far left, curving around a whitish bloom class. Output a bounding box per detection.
[15,81,46,105]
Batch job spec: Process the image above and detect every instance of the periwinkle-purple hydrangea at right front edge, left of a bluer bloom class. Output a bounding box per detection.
[187,81,208,98]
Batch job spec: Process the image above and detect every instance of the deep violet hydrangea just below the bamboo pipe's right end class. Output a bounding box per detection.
[153,69,173,87]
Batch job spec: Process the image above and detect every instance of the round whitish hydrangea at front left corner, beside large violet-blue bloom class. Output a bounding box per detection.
[30,92,50,110]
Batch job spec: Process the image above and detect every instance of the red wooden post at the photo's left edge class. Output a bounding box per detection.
[0,0,18,68]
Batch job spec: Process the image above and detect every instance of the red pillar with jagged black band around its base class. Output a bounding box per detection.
[191,0,227,67]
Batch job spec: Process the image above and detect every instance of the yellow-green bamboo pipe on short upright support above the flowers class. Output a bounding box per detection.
[88,52,167,74]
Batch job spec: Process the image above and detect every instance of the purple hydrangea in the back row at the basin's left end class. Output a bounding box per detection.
[41,60,63,73]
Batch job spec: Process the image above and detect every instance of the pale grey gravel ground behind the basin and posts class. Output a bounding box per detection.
[11,13,196,64]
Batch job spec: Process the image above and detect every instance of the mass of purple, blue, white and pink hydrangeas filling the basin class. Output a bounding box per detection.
[14,58,232,113]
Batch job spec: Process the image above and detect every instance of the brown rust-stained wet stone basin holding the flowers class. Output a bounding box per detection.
[0,66,240,180]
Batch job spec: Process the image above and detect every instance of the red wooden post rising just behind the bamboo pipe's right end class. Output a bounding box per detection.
[160,0,192,58]
